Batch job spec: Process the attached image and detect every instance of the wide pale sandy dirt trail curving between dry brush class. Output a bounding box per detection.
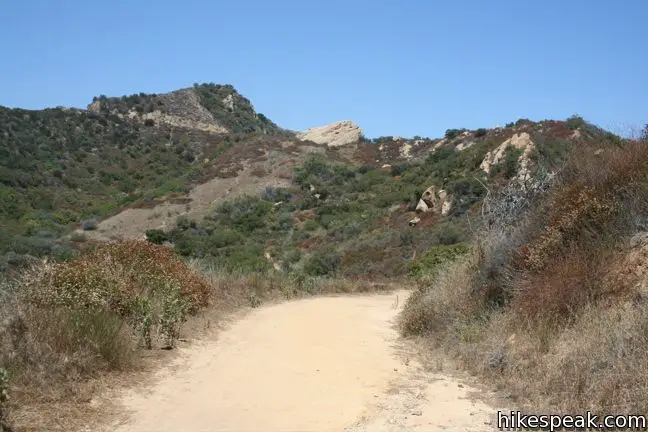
[105,291,493,432]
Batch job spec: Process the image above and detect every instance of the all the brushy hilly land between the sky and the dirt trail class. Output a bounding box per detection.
[0,84,636,430]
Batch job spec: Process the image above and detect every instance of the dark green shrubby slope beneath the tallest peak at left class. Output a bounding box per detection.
[0,85,288,267]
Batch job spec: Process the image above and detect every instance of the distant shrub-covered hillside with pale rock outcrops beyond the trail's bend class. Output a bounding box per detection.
[0,84,617,276]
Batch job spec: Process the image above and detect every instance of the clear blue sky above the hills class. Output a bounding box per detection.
[0,0,648,137]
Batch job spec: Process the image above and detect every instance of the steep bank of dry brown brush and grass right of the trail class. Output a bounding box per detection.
[401,142,648,413]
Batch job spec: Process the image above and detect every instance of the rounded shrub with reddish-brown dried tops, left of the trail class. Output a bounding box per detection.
[25,241,209,350]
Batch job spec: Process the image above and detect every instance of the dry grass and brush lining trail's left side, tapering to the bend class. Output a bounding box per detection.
[0,246,392,431]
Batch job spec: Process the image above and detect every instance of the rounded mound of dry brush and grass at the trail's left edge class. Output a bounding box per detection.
[0,242,211,430]
